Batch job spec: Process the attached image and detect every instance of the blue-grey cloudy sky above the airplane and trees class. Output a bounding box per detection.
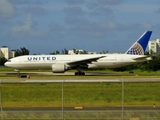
[0,0,160,54]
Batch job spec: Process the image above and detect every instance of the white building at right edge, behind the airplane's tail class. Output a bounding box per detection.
[148,39,160,55]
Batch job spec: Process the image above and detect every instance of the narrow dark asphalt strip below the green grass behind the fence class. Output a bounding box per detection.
[3,105,160,112]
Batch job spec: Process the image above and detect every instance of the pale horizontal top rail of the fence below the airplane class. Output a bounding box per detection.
[0,78,160,84]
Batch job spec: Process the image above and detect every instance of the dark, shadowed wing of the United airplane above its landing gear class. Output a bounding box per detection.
[67,56,106,66]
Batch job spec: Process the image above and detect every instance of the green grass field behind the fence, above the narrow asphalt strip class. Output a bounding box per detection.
[1,83,160,107]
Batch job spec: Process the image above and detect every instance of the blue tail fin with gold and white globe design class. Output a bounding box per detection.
[125,31,152,55]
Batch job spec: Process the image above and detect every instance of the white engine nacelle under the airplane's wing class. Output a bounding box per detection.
[52,63,67,73]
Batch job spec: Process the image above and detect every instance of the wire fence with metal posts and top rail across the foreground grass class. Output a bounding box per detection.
[0,79,160,120]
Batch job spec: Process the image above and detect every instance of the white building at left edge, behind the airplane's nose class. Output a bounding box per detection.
[0,46,15,60]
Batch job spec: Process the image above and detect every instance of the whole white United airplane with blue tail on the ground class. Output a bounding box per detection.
[4,31,152,75]
